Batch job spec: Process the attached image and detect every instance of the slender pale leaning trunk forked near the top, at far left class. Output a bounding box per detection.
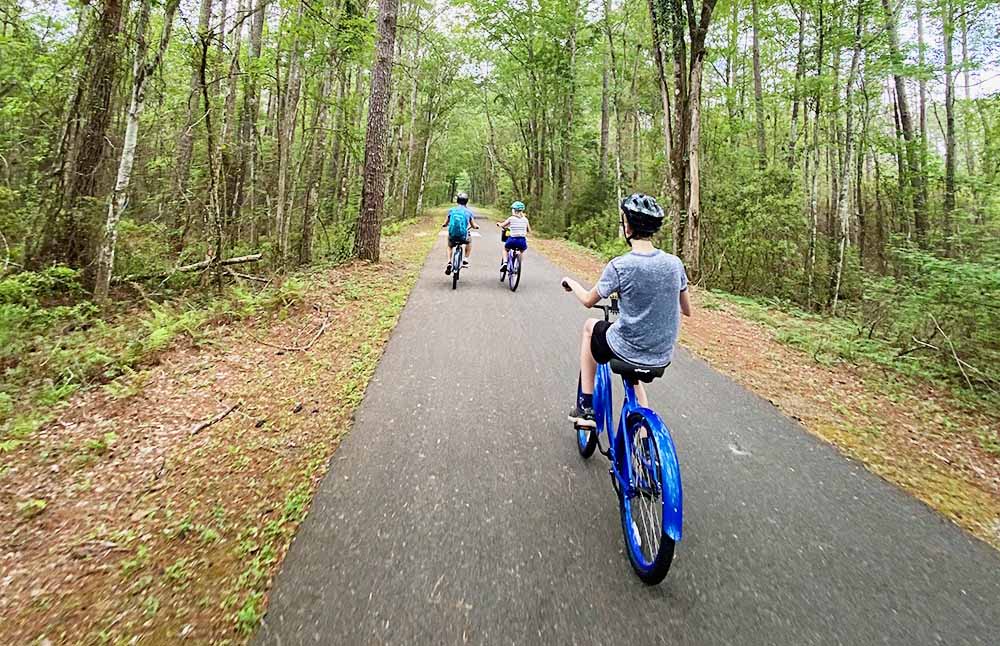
[94,0,179,303]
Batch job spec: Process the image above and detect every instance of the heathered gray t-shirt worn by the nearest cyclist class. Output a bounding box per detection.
[597,249,687,366]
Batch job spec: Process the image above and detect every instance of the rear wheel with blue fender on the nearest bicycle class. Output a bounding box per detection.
[620,413,680,585]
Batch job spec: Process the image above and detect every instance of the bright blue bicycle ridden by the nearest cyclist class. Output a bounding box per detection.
[564,296,682,585]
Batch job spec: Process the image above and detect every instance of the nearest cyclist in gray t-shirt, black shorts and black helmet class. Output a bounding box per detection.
[563,193,691,428]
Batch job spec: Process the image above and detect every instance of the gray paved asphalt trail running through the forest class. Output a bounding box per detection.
[255,226,1000,646]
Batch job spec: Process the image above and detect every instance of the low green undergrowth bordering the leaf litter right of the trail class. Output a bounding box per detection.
[700,290,1000,455]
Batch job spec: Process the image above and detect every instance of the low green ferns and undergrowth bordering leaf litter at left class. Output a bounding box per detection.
[0,267,306,453]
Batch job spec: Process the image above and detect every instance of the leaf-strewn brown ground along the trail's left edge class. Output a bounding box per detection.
[0,216,437,644]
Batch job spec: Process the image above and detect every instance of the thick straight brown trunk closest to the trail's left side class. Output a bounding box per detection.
[354,0,399,262]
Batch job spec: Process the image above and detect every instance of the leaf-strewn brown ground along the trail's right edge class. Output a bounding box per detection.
[531,237,1000,549]
